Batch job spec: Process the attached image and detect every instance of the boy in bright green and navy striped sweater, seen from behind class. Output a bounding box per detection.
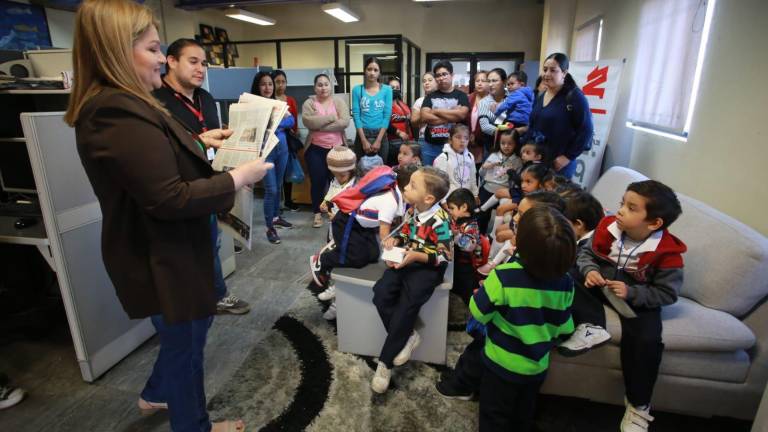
[469,205,576,432]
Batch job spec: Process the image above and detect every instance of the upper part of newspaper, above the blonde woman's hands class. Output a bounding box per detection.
[213,93,288,171]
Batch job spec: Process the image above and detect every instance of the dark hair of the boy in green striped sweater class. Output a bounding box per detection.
[515,205,576,280]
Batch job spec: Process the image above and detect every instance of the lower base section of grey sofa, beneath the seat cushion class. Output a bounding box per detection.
[550,344,751,383]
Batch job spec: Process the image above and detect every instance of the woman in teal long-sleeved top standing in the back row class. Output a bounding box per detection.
[352,57,392,164]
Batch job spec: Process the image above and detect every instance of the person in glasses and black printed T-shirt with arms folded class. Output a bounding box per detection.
[421,60,469,166]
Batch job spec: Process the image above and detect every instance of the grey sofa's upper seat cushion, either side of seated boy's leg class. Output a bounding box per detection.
[605,297,755,352]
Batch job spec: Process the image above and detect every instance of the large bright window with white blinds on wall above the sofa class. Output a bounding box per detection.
[627,0,715,139]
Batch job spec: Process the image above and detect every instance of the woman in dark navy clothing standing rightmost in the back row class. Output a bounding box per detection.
[527,53,594,179]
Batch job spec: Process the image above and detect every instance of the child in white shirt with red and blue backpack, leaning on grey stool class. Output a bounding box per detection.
[309,166,410,321]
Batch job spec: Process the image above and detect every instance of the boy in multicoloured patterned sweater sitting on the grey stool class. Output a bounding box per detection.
[371,167,451,393]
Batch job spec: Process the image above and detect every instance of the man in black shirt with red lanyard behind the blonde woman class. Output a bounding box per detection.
[152,39,251,315]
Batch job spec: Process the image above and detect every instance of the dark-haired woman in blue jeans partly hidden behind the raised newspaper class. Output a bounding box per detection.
[251,72,296,244]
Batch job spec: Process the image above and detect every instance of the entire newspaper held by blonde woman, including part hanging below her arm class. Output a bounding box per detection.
[213,93,288,250]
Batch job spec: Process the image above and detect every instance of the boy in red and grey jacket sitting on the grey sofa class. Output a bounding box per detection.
[558,180,686,432]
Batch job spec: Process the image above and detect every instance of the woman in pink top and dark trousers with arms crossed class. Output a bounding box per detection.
[301,74,350,228]
